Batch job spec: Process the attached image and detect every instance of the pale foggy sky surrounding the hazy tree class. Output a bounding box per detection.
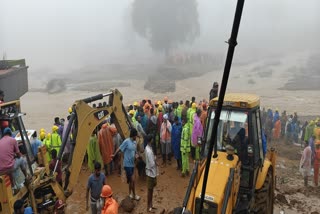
[0,0,320,72]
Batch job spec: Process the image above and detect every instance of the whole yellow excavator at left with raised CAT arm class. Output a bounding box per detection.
[0,89,132,214]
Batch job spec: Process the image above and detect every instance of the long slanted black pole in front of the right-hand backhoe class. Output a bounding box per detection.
[199,0,244,213]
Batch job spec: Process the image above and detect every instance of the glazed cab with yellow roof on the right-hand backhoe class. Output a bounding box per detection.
[204,94,264,193]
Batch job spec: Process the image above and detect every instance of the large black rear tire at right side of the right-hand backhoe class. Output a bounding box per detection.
[252,168,274,214]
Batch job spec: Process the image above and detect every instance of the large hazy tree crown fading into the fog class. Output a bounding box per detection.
[132,0,200,55]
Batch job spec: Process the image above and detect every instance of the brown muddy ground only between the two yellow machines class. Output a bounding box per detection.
[63,157,192,214]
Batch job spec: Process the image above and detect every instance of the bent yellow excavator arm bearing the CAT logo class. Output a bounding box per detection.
[58,89,132,197]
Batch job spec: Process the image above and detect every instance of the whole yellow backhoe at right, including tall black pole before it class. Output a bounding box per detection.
[179,0,276,214]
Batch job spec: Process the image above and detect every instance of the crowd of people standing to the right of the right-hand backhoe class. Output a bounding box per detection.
[261,108,320,187]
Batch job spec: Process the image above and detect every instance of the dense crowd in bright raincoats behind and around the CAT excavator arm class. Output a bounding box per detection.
[26,97,208,213]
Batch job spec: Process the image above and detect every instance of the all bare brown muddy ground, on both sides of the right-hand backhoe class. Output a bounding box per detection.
[63,140,320,214]
